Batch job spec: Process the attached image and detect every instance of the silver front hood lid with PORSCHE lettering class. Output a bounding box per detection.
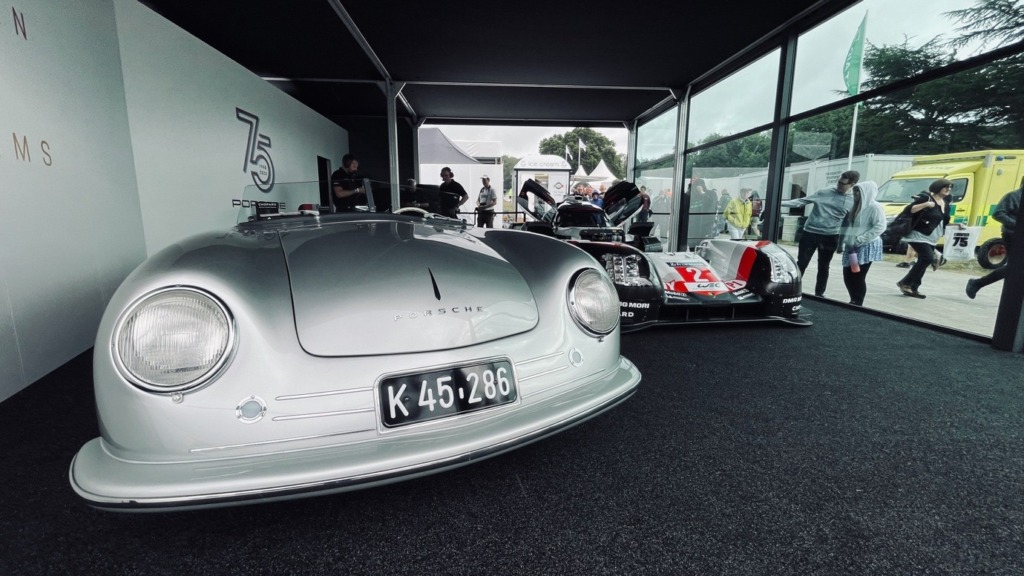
[281,221,538,357]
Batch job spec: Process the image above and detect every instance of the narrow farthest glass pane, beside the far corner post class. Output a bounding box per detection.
[634,108,679,242]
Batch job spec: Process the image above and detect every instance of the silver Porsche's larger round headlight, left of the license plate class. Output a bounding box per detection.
[113,288,234,393]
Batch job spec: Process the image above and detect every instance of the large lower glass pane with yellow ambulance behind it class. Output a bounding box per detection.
[775,54,1024,336]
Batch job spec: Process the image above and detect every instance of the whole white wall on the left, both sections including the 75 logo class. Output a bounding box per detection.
[0,0,348,401]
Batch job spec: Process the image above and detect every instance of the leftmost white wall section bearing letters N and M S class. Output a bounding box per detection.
[0,0,144,400]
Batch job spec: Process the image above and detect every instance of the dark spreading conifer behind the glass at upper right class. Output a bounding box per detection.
[791,0,1024,161]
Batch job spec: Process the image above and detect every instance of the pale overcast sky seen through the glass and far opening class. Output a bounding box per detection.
[425,0,975,158]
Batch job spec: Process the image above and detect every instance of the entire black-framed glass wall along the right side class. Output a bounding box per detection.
[636,0,1024,336]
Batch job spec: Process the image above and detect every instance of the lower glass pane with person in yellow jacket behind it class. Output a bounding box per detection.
[683,130,771,248]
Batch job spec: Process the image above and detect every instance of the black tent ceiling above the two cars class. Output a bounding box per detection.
[139,0,853,126]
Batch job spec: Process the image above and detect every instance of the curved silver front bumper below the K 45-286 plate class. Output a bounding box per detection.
[69,357,640,511]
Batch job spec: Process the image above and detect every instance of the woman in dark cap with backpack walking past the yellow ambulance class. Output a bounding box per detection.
[896,178,953,298]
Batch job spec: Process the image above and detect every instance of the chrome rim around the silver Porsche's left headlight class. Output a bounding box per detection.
[111,285,238,396]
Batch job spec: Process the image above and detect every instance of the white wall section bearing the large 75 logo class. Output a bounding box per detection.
[114,0,348,254]
